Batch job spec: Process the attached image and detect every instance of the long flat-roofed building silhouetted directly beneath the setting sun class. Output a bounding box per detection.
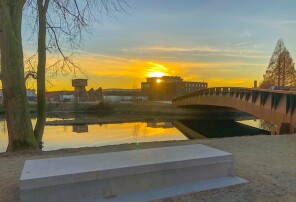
[141,76,208,100]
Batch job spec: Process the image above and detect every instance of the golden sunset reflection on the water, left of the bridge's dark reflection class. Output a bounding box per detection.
[0,120,187,152]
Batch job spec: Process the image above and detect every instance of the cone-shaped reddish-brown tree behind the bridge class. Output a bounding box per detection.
[260,39,296,87]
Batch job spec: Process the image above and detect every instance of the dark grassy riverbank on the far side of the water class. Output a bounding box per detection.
[0,101,250,118]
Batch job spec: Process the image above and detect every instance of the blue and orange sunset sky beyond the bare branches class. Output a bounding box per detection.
[23,0,296,90]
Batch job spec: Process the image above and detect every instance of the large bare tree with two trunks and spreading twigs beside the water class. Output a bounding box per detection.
[0,0,127,151]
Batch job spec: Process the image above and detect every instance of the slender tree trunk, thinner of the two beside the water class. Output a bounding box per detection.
[34,0,48,147]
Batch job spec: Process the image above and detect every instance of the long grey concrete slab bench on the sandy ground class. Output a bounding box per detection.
[20,144,246,202]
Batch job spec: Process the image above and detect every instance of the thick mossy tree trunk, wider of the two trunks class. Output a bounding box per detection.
[0,0,38,151]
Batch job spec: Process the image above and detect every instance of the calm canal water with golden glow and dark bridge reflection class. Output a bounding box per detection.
[0,119,269,152]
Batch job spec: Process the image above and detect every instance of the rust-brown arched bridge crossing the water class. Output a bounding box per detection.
[173,87,296,134]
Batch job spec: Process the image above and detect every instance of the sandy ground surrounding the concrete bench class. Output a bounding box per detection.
[0,135,296,202]
